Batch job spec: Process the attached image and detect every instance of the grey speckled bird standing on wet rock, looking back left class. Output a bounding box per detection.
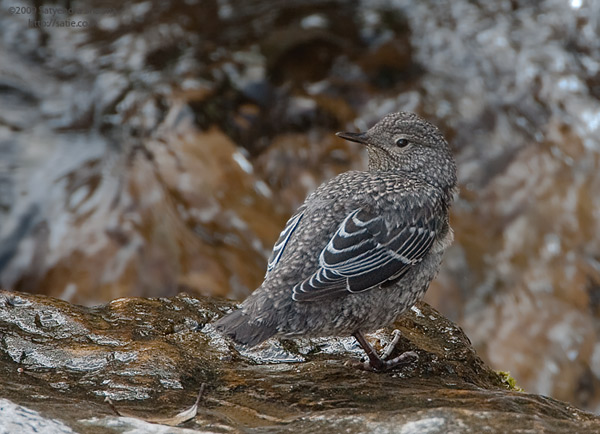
[215,112,456,370]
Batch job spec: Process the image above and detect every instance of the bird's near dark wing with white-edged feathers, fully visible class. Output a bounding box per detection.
[292,197,443,301]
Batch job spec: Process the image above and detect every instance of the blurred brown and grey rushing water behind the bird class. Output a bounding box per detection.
[0,0,600,413]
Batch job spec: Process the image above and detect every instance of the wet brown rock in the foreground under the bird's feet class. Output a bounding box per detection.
[0,291,600,433]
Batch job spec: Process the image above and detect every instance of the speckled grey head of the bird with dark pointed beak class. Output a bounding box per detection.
[337,112,456,189]
